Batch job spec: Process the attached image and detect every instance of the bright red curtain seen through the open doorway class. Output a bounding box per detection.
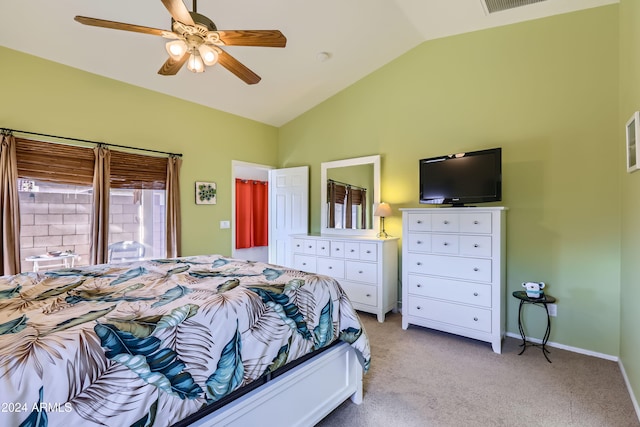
[236,179,269,249]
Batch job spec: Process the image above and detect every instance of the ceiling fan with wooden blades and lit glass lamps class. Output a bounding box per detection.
[74,0,287,84]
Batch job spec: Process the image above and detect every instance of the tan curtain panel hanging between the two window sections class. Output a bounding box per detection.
[91,145,111,264]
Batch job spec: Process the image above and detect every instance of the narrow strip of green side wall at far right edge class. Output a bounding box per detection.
[617,0,640,411]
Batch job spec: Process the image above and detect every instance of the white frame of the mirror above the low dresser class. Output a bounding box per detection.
[320,154,380,237]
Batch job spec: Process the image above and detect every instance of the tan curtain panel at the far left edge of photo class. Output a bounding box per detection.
[0,134,20,275]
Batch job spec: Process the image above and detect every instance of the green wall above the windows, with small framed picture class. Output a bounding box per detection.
[0,47,278,255]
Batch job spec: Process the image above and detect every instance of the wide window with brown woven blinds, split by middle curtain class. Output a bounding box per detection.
[16,138,167,271]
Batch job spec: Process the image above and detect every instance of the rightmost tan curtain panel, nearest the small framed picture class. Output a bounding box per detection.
[165,156,182,258]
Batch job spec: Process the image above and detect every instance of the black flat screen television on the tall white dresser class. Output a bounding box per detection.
[420,148,502,206]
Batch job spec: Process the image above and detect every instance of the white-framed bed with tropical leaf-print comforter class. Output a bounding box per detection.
[0,255,370,427]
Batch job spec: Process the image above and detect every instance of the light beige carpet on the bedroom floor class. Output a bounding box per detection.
[318,313,640,427]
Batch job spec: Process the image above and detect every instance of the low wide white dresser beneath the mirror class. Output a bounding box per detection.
[292,235,398,322]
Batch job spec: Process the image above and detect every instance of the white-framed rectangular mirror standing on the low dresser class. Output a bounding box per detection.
[320,155,380,236]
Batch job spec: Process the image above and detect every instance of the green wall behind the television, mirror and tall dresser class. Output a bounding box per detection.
[279,5,620,356]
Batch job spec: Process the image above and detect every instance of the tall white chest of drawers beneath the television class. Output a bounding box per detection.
[401,207,506,353]
